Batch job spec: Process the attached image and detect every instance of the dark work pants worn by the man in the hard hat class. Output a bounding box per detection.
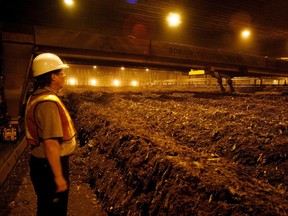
[30,156,69,216]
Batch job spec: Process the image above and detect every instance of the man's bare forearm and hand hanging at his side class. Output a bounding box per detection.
[43,139,68,192]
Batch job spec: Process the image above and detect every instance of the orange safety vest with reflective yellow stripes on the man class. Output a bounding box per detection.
[25,91,76,145]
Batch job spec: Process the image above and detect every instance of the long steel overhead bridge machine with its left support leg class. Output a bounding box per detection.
[1,25,288,142]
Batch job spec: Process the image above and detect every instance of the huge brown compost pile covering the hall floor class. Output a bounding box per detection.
[65,86,288,215]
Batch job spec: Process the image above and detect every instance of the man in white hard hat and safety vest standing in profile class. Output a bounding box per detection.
[25,53,76,216]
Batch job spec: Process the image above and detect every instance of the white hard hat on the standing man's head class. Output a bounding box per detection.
[32,53,69,77]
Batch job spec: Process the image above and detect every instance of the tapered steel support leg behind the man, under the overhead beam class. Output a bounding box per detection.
[2,25,34,141]
